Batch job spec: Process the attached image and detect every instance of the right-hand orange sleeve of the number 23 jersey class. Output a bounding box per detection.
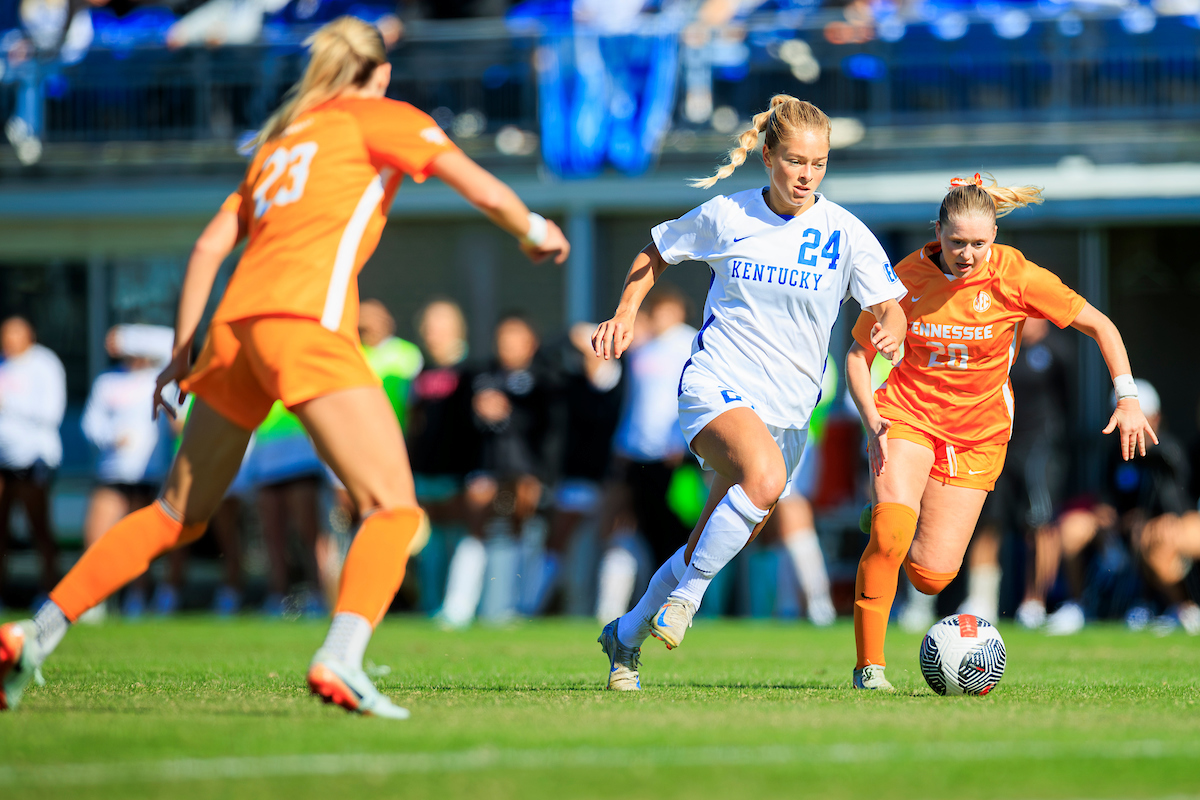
[355,100,458,184]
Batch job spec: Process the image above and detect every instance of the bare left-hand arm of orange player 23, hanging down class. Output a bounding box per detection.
[151,203,246,419]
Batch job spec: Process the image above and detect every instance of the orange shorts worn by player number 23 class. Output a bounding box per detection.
[179,317,380,431]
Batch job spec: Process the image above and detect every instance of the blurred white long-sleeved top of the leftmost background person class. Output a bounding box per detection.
[0,344,67,469]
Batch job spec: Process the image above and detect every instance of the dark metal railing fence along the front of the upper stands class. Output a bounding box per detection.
[9,18,1200,144]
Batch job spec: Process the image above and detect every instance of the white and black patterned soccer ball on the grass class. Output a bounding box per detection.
[920,614,1004,694]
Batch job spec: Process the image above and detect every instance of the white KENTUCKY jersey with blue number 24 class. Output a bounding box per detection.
[652,190,907,428]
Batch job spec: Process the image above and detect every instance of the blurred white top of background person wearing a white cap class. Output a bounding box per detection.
[82,367,175,483]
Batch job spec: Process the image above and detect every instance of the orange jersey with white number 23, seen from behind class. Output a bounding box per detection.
[212,97,456,342]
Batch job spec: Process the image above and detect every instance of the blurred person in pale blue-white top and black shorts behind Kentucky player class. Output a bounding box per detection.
[596,289,696,620]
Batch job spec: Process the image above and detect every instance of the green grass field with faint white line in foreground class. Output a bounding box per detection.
[0,618,1200,800]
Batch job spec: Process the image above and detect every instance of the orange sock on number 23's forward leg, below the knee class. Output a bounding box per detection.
[334,507,425,625]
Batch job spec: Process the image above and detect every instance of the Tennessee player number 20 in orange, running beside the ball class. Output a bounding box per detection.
[846,174,1158,690]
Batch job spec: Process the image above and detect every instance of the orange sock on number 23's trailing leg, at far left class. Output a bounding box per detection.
[50,501,208,622]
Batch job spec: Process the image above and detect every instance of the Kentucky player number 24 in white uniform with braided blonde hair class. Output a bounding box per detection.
[592,95,906,690]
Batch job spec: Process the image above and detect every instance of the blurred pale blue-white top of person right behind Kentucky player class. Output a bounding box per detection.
[613,324,696,464]
